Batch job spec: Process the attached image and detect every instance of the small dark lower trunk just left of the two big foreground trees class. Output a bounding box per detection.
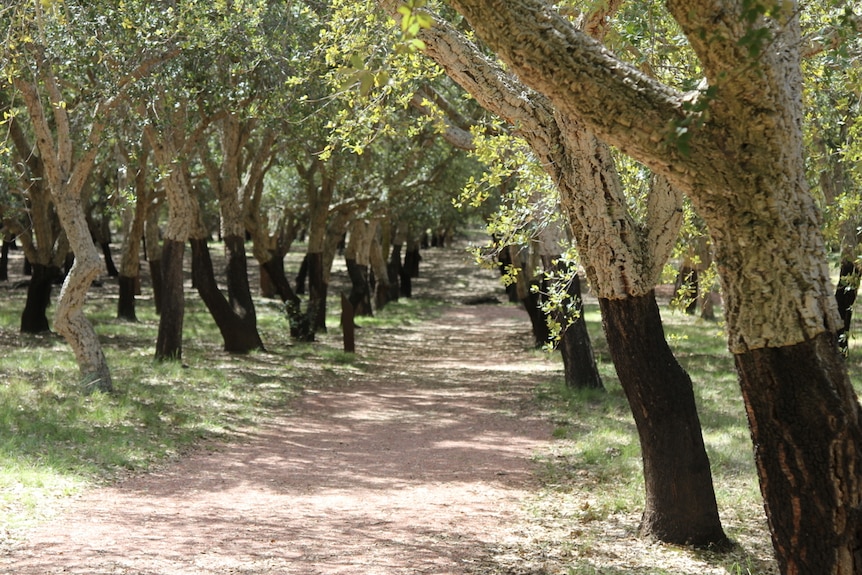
[557,274,604,389]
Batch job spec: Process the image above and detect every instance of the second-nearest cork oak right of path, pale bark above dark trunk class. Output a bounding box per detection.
[381,0,726,544]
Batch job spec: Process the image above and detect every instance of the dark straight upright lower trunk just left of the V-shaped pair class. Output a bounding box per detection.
[155,238,185,360]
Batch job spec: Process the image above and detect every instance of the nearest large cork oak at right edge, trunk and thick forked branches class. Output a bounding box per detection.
[426,0,862,574]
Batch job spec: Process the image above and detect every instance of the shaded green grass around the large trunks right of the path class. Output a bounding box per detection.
[532,305,862,575]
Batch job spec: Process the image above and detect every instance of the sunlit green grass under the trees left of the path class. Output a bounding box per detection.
[0,292,312,533]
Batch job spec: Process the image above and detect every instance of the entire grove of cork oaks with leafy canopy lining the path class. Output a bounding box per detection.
[0,0,862,574]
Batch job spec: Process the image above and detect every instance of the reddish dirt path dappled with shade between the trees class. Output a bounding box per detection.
[0,292,558,575]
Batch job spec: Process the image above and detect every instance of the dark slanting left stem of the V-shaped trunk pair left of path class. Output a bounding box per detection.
[189,239,263,353]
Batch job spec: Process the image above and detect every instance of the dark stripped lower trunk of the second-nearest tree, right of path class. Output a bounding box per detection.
[599,292,727,546]
